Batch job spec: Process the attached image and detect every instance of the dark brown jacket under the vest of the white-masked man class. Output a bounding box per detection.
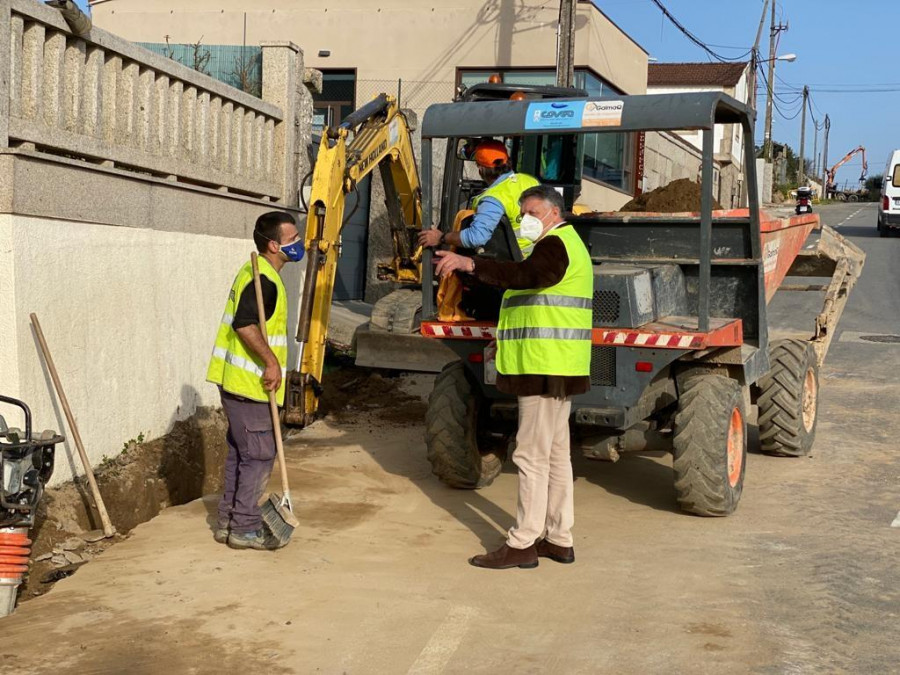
[472,230,591,398]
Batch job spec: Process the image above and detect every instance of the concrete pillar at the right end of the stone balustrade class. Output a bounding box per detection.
[261,42,304,207]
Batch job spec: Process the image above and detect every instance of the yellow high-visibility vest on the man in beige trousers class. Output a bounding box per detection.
[497,225,594,376]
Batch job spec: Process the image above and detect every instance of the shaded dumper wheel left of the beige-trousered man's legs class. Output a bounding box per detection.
[425,362,506,489]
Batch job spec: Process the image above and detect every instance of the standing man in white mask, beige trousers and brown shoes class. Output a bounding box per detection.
[435,186,594,569]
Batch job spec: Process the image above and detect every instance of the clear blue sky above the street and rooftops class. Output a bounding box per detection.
[593,0,900,184]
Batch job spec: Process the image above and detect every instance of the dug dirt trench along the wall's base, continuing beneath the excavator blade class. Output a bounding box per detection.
[18,366,425,603]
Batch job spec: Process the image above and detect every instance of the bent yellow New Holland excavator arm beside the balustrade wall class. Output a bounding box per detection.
[283,94,422,427]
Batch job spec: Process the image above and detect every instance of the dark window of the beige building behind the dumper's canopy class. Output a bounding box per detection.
[459,69,634,193]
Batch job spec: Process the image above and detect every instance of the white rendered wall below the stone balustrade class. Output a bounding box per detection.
[0,215,302,484]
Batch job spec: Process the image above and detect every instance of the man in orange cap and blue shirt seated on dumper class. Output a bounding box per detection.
[419,139,538,256]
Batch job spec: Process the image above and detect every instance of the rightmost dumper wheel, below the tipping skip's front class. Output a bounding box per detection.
[756,340,819,457]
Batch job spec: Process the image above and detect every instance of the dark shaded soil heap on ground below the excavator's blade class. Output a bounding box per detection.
[319,366,427,425]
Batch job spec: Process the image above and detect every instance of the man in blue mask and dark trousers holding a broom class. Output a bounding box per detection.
[206,211,304,550]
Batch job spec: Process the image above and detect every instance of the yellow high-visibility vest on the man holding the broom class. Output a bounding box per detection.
[206,256,287,405]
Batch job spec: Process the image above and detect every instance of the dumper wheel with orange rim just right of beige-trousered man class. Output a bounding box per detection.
[672,373,747,516]
